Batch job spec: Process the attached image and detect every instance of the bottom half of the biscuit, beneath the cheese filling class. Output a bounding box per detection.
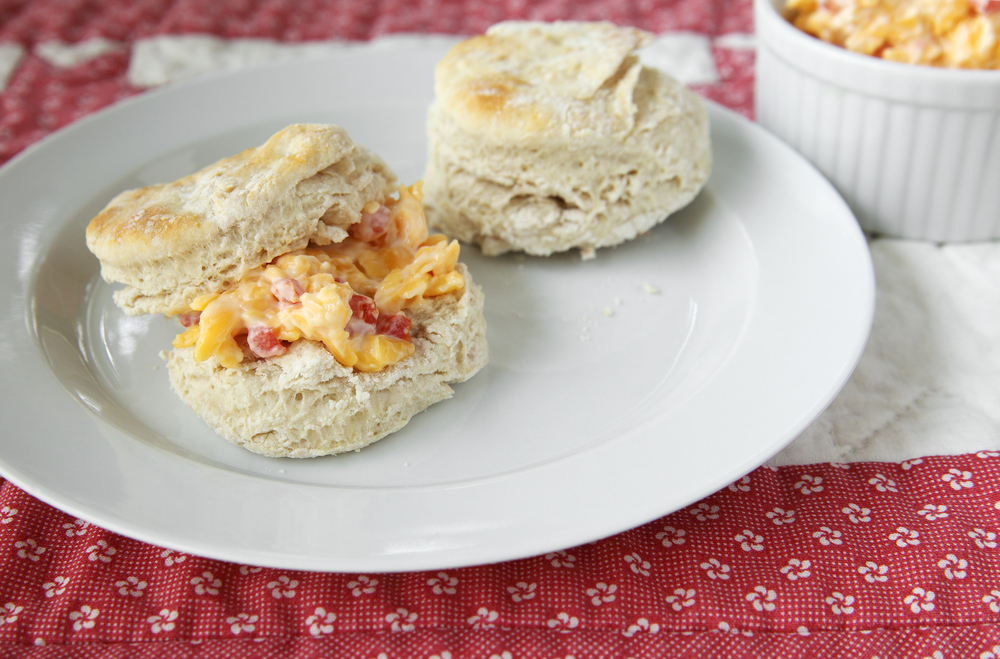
[164,264,488,458]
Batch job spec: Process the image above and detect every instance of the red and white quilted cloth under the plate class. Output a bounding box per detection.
[0,0,1000,659]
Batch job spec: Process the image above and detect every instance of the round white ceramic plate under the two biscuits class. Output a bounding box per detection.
[0,45,874,572]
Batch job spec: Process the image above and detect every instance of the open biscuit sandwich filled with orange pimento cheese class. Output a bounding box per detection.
[87,125,487,458]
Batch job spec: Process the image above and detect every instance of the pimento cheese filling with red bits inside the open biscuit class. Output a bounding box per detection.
[173,183,465,372]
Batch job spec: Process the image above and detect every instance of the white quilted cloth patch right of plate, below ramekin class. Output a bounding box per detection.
[771,238,1000,466]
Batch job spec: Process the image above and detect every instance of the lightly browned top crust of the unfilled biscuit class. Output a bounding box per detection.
[435,21,653,141]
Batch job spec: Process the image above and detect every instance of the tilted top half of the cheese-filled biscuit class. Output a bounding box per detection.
[86,124,396,315]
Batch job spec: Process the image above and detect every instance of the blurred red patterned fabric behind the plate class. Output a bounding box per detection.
[0,0,753,163]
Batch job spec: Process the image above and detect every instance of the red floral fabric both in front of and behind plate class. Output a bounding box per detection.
[0,0,1000,659]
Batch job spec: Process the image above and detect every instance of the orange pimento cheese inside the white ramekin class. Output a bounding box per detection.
[785,0,1000,69]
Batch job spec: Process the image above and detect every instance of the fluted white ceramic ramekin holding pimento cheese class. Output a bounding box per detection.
[754,0,1000,241]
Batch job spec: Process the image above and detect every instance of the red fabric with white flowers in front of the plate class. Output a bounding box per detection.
[0,453,1000,659]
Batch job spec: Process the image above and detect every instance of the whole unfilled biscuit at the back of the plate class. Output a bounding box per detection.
[424,21,712,258]
